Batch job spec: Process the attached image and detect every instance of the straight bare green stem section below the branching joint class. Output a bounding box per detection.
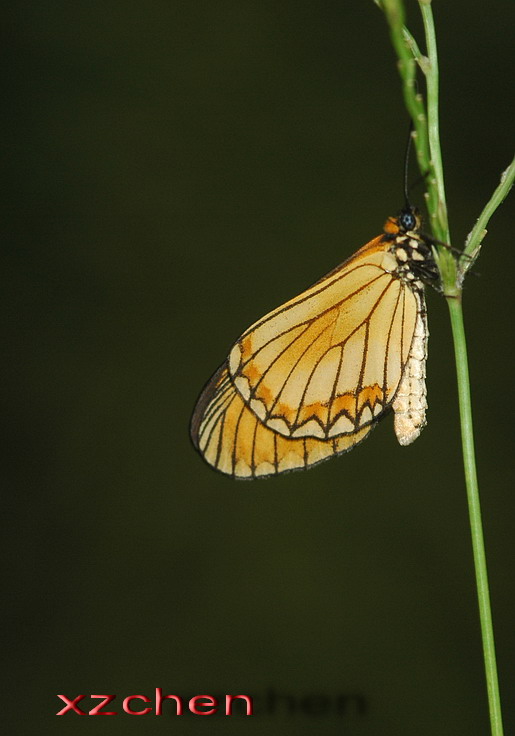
[447,297,503,736]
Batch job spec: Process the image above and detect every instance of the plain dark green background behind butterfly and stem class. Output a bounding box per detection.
[5,0,515,736]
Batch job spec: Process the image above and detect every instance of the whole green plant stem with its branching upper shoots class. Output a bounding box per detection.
[375,0,508,736]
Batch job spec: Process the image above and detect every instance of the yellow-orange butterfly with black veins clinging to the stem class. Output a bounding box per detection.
[190,204,439,479]
